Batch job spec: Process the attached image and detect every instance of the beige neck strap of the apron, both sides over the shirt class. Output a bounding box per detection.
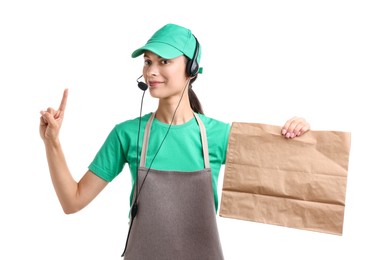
[140,113,210,168]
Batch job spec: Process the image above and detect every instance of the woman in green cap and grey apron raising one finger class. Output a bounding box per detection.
[40,24,309,259]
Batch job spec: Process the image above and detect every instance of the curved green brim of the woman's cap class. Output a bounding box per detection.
[131,42,183,59]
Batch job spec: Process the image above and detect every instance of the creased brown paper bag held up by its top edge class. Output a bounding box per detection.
[219,122,351,235]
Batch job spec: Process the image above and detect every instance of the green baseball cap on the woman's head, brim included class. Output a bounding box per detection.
[131,24,201,71]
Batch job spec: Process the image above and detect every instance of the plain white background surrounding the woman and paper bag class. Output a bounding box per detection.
[0,0,377,260]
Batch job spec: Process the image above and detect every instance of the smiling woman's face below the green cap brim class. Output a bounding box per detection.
[143,51,189,99]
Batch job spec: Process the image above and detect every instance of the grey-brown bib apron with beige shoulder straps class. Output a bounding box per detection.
[124,113,224,260]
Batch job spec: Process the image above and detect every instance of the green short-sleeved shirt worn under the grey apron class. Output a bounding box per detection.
[89,113,230,210]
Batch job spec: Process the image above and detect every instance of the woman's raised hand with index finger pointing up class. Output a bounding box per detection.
[39,89,68,143]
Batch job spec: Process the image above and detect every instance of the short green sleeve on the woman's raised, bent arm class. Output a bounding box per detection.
[88,127,126,182]
